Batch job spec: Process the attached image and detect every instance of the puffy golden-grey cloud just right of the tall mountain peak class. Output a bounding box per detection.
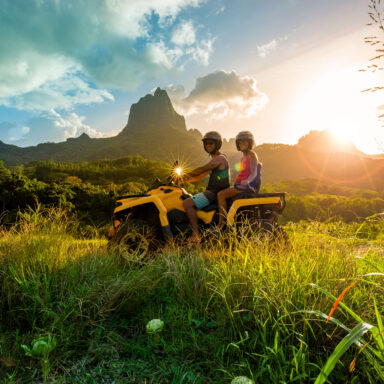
[166,70,268,119]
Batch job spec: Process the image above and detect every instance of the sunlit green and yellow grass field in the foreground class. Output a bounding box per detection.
[0,210,384,384]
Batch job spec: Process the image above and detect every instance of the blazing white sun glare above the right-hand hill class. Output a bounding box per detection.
[286,68,377,153]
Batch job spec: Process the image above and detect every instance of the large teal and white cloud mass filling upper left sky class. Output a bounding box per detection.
[0,0,213,110]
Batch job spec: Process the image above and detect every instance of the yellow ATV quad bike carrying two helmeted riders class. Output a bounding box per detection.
[108,164,287,254]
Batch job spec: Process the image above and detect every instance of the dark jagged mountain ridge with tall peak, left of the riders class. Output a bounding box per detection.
[0,88,205,165]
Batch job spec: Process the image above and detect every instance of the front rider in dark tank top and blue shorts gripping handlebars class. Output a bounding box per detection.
[178,131,229,243]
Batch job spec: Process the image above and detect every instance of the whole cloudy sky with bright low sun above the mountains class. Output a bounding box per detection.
[0,0,384,154]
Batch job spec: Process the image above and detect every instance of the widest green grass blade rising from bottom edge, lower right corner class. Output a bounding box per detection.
[315,322,373,384]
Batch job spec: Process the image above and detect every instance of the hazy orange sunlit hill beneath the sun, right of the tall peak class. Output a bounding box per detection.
[219,131,384,191]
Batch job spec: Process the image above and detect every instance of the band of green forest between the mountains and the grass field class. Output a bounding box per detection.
[0,156,384,232]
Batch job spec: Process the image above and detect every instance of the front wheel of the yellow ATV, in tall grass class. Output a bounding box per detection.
[110,219,160,259]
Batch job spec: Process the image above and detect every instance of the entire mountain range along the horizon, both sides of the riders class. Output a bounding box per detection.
[0,88,384,190]
